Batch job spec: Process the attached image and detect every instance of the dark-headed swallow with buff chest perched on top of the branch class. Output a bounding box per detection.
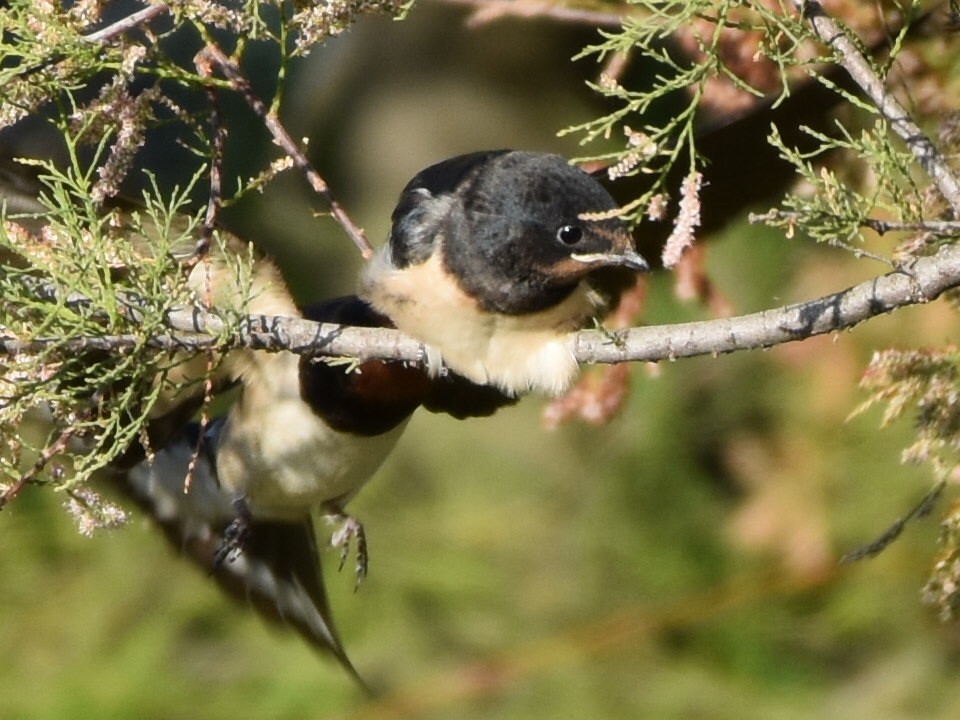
[359,150,648,396]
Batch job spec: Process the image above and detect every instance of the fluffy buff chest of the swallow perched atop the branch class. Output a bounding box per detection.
[360,253,598,395]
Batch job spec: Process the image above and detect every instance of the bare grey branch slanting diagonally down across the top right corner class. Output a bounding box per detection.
[794,0,960,218]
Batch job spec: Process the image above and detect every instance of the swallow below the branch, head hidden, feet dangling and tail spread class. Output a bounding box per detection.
[121,288,429,682]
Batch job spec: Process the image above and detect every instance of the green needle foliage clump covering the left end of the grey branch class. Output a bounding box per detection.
[0,129,219,500]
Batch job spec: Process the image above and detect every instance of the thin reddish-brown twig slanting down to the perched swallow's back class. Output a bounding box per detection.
[200,43,373,260]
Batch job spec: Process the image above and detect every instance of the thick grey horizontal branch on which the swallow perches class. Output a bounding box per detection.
[0,240,960,363]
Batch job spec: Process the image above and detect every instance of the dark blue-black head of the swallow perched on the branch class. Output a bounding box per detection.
[390,150,647,315]
